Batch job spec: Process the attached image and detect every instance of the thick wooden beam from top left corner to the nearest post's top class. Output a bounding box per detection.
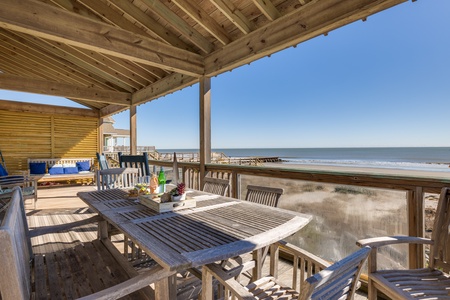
[0,0,204,76]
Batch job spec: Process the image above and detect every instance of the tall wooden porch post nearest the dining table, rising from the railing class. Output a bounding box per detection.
[199,77,211,189]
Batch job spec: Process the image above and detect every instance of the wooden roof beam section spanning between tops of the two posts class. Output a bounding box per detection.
[131,73,198,105]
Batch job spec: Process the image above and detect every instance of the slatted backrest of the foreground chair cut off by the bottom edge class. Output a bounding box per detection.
[298,247,370,300]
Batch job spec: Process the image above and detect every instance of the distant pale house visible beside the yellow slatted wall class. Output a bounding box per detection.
[103,117,130,152]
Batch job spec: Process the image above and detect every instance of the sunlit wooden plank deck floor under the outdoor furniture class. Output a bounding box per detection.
[26,186,367,300]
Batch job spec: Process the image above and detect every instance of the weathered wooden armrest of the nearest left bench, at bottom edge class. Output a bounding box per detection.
[78,265,176,300]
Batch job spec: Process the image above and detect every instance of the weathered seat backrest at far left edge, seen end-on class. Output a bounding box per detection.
[0,187,33,299]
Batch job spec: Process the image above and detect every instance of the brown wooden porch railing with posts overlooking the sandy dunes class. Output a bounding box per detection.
[150,160,450,268]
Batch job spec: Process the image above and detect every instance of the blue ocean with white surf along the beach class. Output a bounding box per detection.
[163,147,450,172]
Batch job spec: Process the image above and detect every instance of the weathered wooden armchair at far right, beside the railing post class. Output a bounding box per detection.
[357,188,450,299]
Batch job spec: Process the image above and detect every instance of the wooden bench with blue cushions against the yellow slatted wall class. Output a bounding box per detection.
[28,157,95,183]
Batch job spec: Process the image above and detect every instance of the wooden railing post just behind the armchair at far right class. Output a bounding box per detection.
[407,187,425,269]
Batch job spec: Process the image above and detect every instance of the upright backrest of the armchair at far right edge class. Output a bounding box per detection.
[429,187,450,273]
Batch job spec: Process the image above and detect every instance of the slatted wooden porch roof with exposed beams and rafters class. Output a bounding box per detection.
[0,0,405,117]
